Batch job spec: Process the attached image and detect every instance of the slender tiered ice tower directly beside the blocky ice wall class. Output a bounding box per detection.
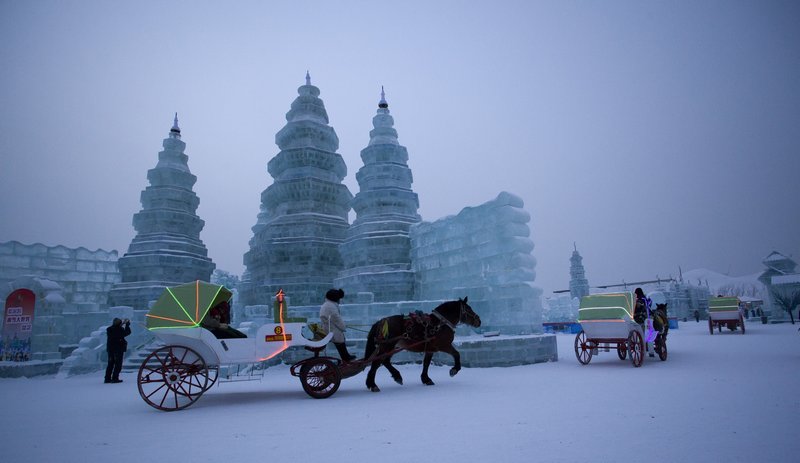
[334,87,421,302]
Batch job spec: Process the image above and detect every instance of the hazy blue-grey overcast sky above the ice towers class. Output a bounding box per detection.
[0,0,800,295]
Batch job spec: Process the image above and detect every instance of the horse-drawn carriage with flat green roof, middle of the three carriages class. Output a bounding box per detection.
[575,292,667,367]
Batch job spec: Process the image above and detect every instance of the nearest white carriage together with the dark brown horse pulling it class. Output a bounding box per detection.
[137,281,480,411]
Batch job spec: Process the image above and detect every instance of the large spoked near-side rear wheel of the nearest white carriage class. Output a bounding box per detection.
[137,346,211,412]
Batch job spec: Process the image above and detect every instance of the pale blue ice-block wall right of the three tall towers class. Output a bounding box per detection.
[411,192,542,334]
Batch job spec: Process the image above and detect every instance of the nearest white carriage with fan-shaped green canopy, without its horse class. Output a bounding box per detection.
[137,281,341,411]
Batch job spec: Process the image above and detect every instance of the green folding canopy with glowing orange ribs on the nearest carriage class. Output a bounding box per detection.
[145,280,233,330]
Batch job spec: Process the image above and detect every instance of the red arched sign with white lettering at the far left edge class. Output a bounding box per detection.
[0,288,36,362]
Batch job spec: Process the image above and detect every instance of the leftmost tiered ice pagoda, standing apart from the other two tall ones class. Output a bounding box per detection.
[109,114,216,310]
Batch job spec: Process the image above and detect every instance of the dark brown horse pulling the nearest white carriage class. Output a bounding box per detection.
[364,297,481,392]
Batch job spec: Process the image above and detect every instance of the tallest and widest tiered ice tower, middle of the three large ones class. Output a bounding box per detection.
[239,73,353,305]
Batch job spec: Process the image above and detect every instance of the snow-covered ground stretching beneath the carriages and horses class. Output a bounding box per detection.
[0,322,800,463]
